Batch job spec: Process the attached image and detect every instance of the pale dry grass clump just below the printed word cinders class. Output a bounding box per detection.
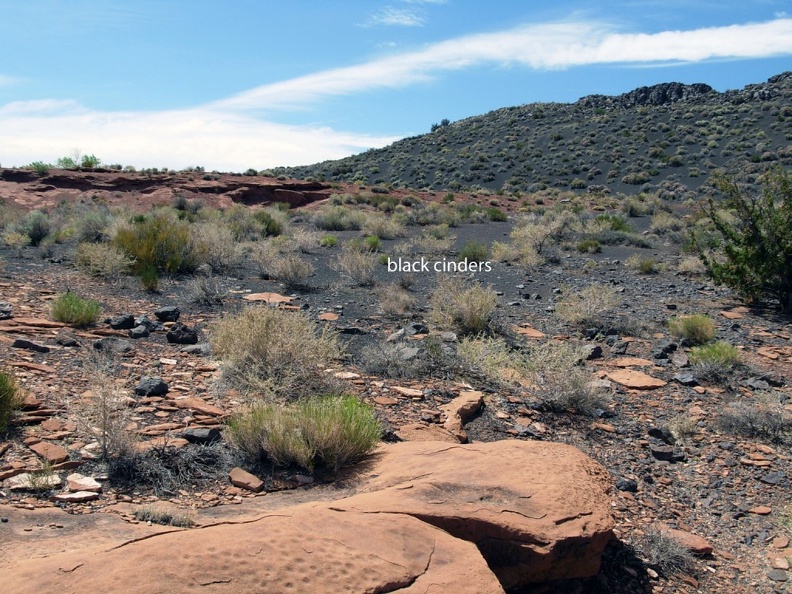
[429,276,498,334]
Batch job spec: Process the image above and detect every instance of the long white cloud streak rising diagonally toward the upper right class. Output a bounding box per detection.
[209,18,792,110]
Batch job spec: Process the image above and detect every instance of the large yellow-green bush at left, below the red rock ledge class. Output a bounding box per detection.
[113,211,195,274]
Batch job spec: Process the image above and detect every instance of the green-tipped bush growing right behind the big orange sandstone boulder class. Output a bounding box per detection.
[228,395,382,471]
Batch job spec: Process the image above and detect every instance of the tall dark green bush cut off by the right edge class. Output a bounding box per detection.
[691,168,792,312]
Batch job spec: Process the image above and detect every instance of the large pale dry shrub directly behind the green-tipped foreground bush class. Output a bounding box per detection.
[210,306,341,396]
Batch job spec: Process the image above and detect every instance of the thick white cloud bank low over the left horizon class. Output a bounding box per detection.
[0,101,397,171]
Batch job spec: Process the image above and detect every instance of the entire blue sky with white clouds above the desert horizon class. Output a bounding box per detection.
[0,0,792,171]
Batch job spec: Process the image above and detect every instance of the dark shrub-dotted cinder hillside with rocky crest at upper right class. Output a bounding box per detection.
[276,72,792,196]
